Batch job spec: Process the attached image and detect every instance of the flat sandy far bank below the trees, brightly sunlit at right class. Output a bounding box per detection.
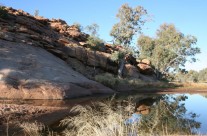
[115,82,207,94]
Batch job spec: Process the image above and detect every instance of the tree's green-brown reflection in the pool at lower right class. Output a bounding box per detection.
[135,95,201,135]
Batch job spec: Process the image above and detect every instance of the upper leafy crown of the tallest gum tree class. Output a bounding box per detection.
[110,4,147,46]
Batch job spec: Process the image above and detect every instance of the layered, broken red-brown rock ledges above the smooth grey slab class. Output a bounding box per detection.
[0,8,118,78]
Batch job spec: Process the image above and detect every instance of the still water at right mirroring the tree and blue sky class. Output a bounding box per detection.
[111,94,207,135]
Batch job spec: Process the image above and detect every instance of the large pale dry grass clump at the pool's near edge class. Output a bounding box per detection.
[61,99,138,136]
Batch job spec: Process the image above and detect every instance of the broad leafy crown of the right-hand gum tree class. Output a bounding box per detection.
[138,24,200,78]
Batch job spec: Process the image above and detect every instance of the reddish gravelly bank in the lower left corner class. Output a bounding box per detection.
[0,103,67,136]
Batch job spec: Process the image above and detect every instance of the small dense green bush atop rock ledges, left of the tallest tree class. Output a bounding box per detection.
[87,36,105,51]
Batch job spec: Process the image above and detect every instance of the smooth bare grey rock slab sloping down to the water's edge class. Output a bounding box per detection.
[0,40,114,99]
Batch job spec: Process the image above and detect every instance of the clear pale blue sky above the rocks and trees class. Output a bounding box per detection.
[0,0,207,71]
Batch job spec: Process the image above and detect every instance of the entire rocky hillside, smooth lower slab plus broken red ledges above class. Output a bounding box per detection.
[0,8,157,99]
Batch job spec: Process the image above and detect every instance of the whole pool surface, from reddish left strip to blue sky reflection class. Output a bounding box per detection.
[0,94,207,134]
